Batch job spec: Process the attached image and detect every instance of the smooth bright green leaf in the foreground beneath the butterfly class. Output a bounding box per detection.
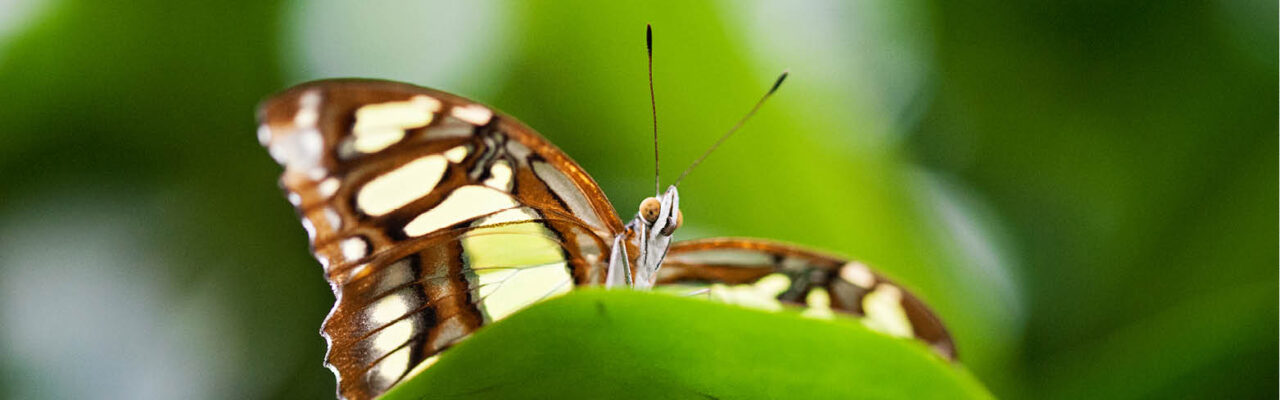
[384,290,991,399]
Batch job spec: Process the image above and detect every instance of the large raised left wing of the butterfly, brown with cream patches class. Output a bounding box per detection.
[259,79,623,399]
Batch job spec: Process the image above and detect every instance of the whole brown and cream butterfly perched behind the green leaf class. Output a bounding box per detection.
[257,29,955,399]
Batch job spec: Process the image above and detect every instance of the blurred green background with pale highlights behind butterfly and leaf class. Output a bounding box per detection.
[0,0,1280,399]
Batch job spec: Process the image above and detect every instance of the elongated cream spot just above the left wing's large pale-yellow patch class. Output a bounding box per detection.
[404,185,517,237]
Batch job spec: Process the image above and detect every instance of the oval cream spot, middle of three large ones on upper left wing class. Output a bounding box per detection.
[356,154,447,217]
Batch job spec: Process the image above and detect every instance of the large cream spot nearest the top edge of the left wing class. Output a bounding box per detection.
[352,95,440,154]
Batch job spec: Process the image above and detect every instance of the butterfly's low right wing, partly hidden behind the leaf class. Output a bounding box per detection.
[658,238,956,359]
